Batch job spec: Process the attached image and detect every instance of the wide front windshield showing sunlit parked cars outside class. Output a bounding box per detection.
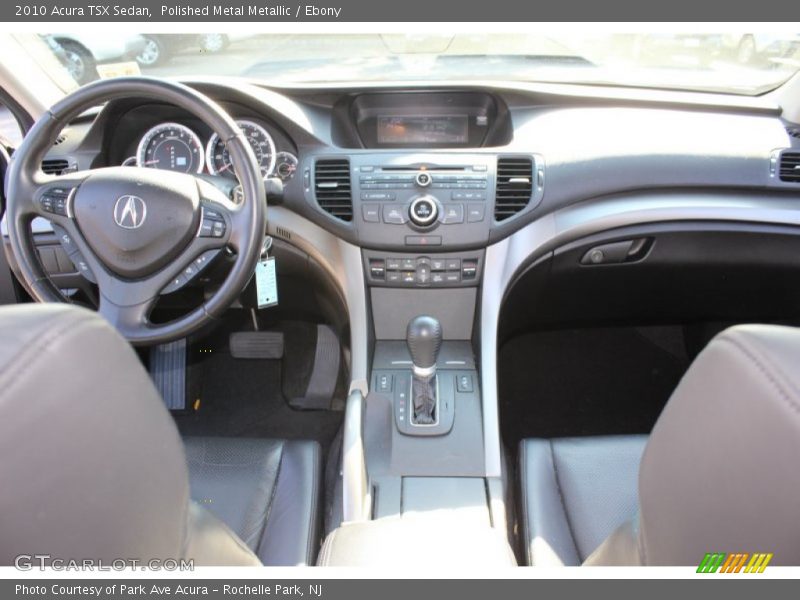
[10,30,800,95]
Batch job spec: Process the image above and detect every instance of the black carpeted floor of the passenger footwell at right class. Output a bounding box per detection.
[498,327,689,449]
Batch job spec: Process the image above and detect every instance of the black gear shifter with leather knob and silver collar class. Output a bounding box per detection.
[406,316,442,425]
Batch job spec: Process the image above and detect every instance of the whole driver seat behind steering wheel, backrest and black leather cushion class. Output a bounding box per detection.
[0,304,321,566]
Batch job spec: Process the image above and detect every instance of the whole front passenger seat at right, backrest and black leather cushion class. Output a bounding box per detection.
[520,325,800,566]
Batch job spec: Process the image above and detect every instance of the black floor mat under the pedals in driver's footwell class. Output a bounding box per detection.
[175,318,343,452]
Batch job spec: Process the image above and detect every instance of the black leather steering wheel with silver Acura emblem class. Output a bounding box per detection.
[6,77,266,345]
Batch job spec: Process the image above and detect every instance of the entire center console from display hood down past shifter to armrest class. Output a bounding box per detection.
[316,95,528,564]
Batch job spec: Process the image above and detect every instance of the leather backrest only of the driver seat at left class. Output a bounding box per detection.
[0,304,189,565]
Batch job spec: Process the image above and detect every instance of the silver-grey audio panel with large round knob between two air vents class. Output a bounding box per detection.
[350,153,496,251]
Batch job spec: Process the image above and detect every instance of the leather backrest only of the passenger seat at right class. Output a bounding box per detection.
[639,325,800,566]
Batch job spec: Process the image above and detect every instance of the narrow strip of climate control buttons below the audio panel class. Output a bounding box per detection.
[363,250,483,288]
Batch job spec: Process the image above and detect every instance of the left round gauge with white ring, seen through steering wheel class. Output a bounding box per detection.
[136,123,204,173]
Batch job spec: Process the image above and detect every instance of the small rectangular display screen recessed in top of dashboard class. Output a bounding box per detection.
[378,115,469,145]
